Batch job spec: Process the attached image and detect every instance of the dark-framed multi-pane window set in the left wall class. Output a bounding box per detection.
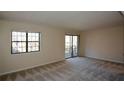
[11,31,40,54]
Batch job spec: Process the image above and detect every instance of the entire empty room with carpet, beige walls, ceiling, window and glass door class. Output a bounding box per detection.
[0,11,124,81]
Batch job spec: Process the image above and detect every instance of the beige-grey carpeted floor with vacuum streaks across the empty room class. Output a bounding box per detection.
[0,57,124,81]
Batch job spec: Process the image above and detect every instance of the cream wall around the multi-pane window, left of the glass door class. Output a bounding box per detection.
[0,20,65,74]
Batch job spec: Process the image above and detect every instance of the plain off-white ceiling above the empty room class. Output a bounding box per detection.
[0,11,124,31]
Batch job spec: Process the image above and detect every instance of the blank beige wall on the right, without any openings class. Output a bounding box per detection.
[81,26,124,63]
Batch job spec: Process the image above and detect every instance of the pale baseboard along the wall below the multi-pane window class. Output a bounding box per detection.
[0,59,65,76]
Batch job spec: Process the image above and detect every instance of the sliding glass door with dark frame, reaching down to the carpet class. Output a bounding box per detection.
[65,35,79,58]
